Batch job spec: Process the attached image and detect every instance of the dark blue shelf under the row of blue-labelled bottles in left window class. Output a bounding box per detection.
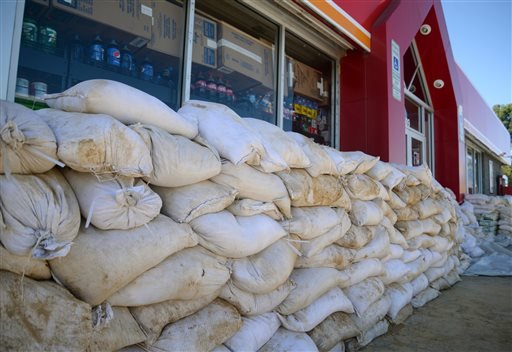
[69,60,177,108]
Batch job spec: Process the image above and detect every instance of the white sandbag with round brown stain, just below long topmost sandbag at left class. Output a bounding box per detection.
[37,109,153,177]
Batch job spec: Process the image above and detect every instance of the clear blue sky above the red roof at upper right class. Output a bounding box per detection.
[442,0,512,107]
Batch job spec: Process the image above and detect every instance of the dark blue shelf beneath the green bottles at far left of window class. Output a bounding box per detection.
[19,45,68,76]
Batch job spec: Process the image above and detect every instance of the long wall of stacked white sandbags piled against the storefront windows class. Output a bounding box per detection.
[0,80,463,351]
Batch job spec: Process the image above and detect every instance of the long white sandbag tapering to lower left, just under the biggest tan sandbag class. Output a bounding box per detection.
[107,246,230,307]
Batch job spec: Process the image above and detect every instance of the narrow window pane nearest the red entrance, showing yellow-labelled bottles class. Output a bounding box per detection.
[283,32,334,145]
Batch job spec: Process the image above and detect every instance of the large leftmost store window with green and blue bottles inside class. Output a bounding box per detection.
[16,0,185,109]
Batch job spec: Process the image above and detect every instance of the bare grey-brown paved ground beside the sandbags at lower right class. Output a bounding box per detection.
[362,276,512,352]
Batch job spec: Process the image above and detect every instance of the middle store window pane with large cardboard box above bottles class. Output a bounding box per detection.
[190,0,278,124]
